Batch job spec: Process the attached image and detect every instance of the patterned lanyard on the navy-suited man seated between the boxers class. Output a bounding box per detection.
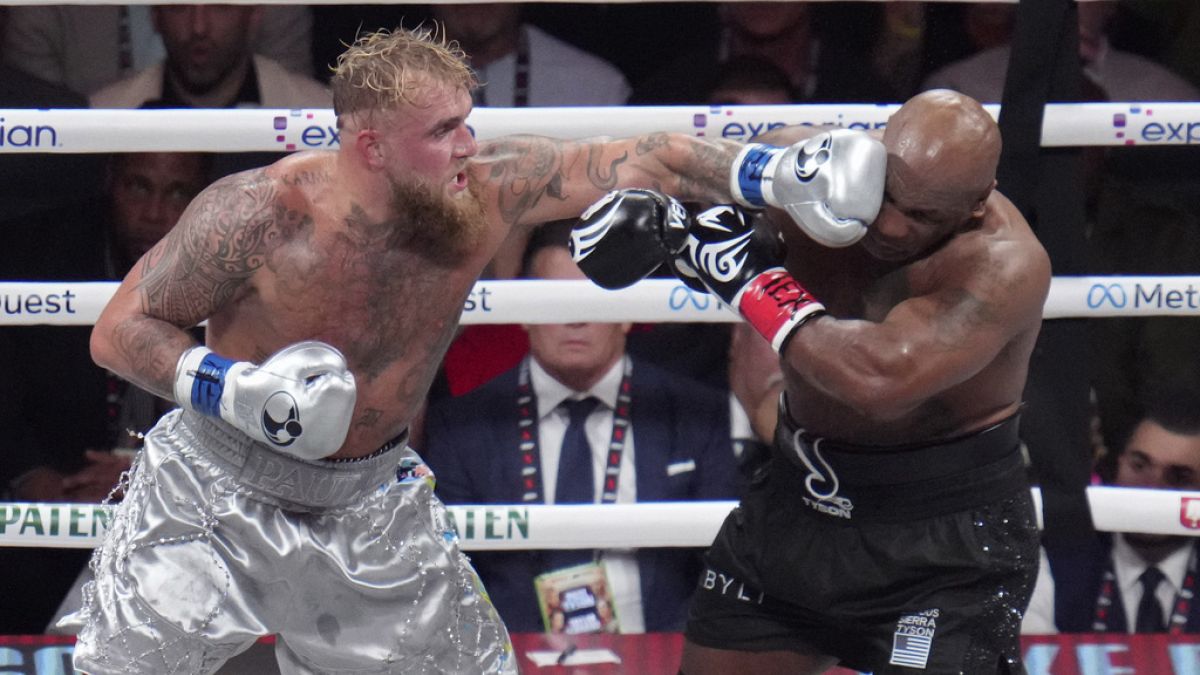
[517,357,634,504]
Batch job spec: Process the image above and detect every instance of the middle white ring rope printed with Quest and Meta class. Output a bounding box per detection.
[0,276,1200,325]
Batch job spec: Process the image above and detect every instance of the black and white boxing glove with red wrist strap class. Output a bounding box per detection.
[678,204,824,352]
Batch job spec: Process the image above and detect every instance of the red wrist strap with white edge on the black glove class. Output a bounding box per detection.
[733,267,824,352]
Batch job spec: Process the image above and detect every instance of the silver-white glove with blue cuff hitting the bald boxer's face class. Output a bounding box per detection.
[730,129,888,247]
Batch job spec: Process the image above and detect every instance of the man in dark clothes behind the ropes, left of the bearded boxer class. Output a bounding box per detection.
[0,153,210,634]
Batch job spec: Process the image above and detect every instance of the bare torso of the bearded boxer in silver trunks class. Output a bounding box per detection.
[200,156,494,458]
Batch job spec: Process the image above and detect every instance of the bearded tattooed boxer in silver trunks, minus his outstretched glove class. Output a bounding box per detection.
[74,30,758,674]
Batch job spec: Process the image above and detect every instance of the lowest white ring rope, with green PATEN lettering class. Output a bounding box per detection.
[0,485,1200,551]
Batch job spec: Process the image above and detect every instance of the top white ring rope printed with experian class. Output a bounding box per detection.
[0,102,1200,153]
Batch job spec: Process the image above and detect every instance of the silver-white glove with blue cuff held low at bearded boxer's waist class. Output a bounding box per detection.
[175,341,358,460]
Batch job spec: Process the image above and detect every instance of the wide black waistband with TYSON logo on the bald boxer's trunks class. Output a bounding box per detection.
[772,403,1028,522]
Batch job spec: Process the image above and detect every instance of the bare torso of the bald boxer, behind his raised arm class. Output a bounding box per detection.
[782,196,1045,444]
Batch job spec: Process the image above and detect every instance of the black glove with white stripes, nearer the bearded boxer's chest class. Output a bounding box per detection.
[570,190,688,291]
